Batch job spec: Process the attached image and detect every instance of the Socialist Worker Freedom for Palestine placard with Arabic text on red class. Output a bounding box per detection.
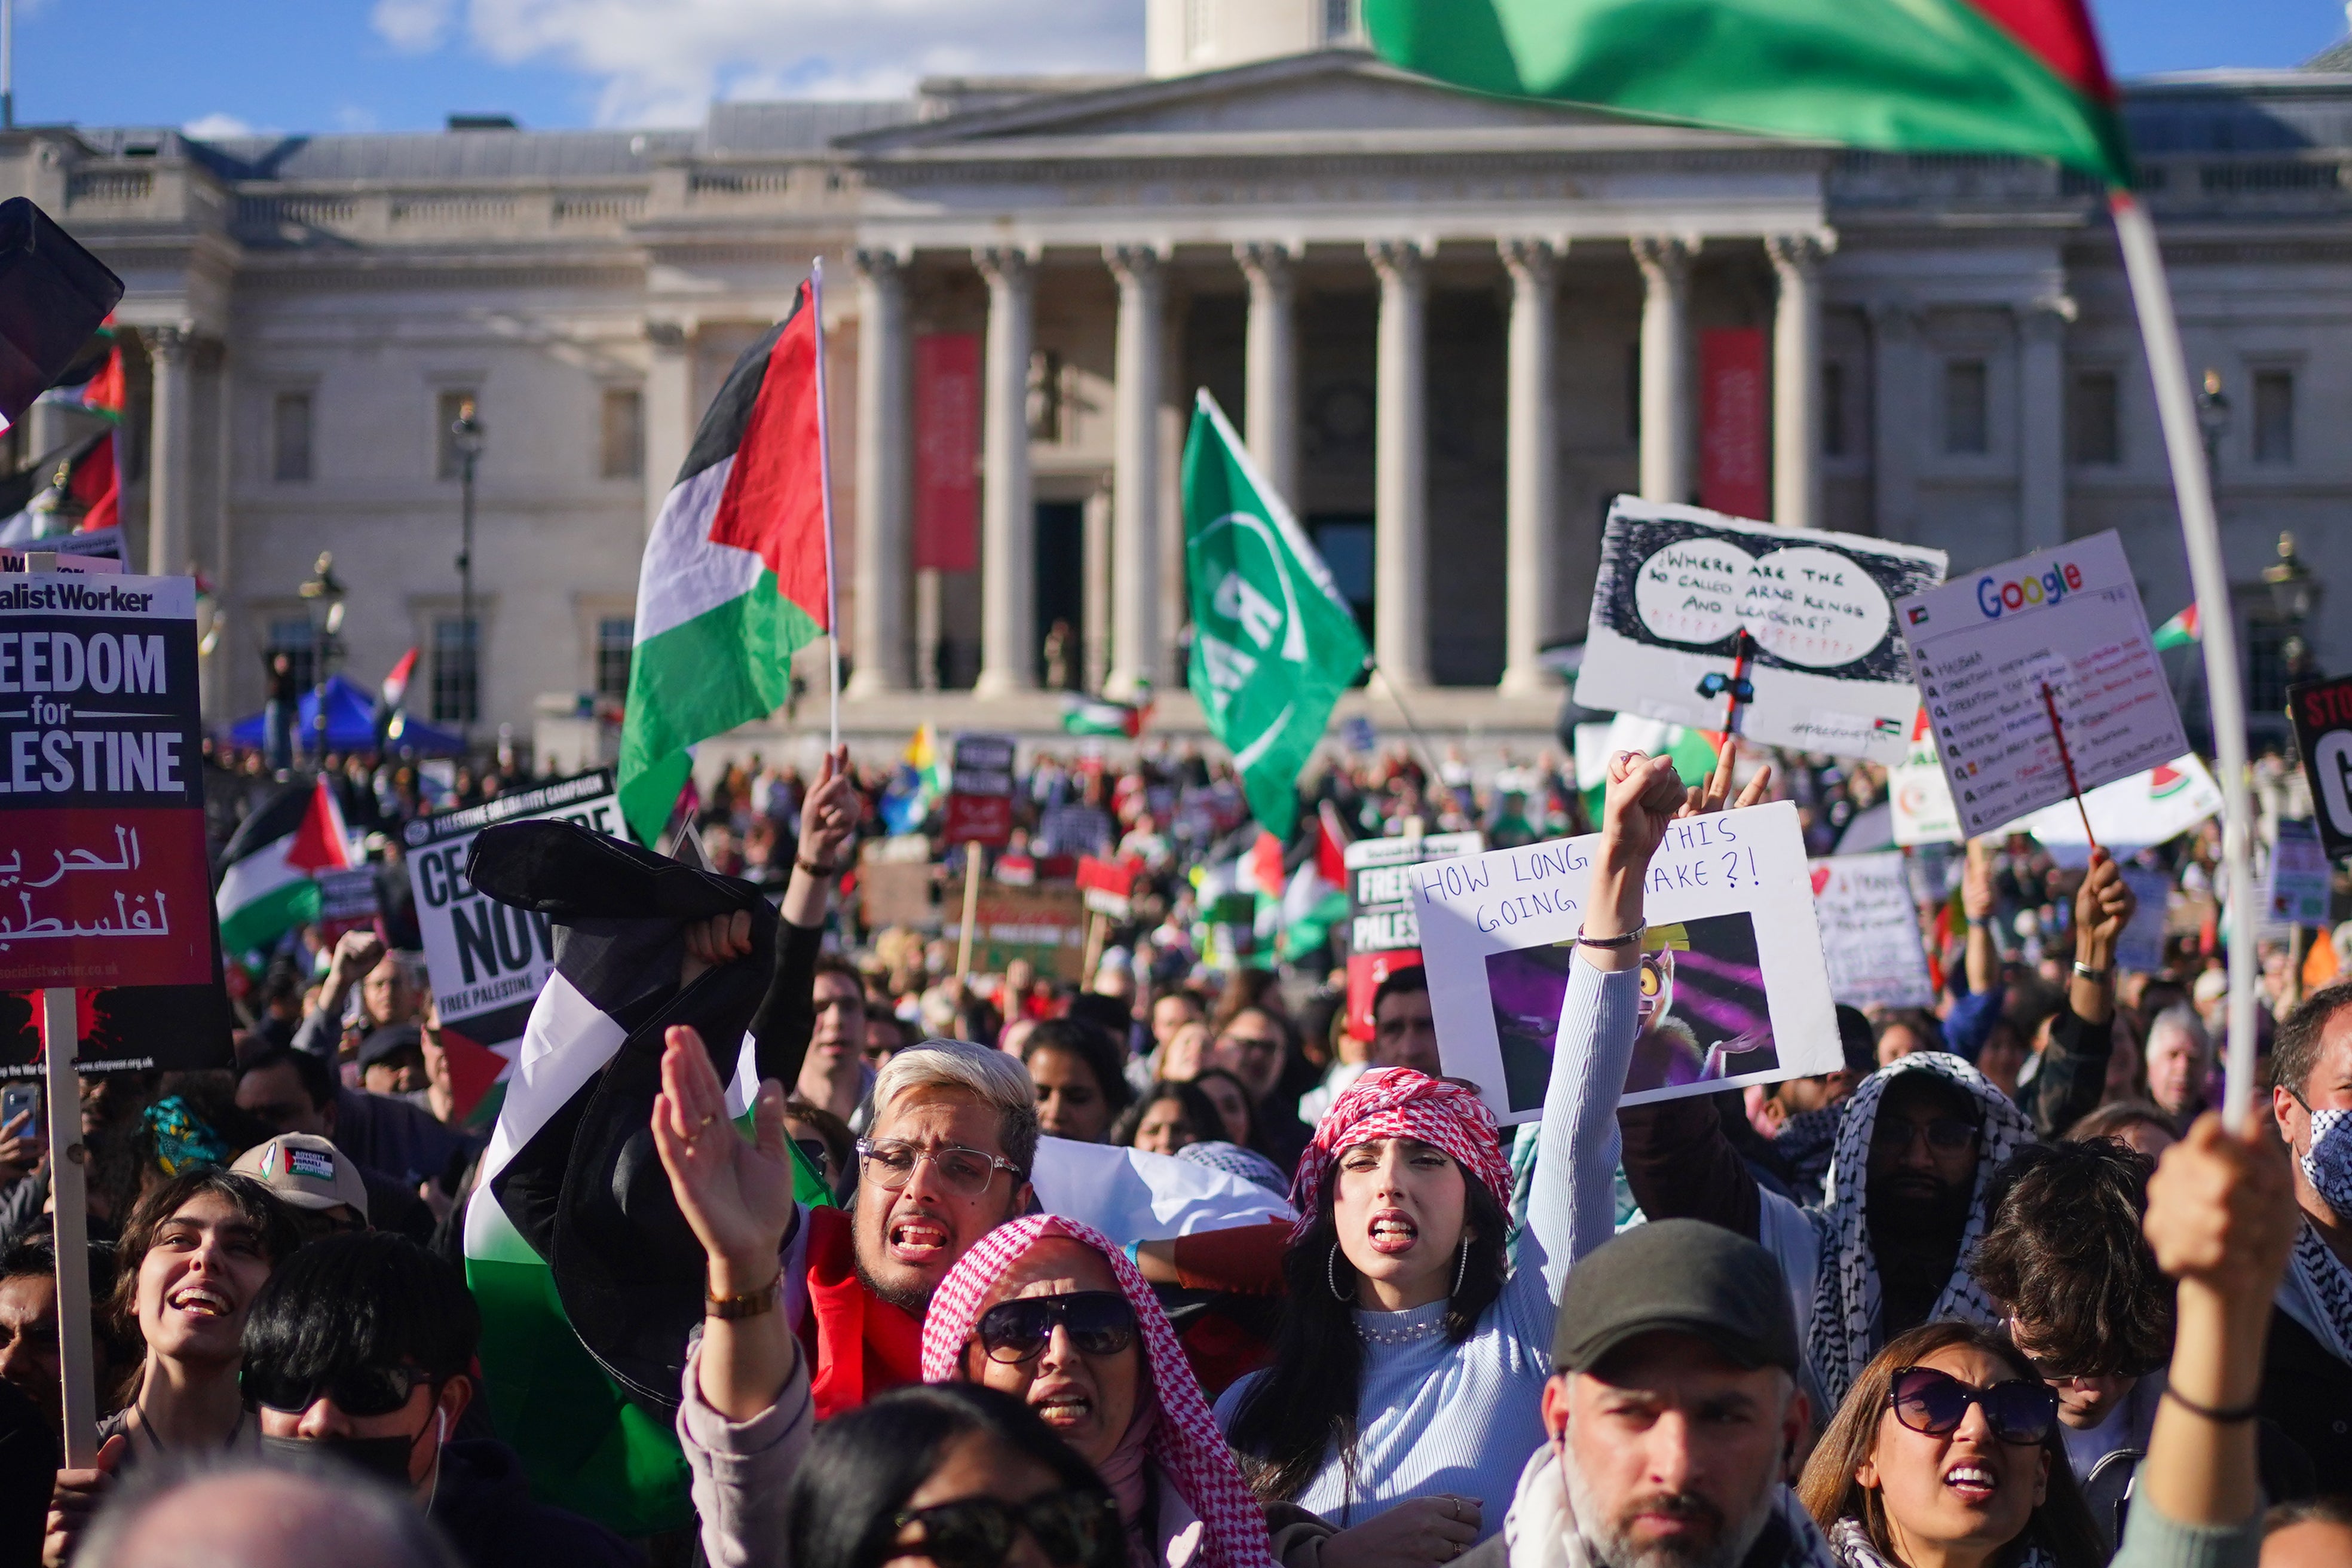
[0,574,214,992]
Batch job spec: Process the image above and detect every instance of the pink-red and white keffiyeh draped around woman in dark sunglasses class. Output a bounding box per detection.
[922,1213,1275,1568]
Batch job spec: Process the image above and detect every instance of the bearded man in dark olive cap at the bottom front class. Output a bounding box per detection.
[1456,1220,1837,1568]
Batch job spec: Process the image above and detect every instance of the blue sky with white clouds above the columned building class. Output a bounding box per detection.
[17,0,2345,131]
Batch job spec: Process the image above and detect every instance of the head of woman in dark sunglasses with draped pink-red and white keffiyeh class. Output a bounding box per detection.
[922,1215,1272,1568]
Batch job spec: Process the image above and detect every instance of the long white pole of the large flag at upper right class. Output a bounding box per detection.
[2108,191,2253,1131]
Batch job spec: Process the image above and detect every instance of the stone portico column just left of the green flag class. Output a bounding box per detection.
[1103,244,1166,700]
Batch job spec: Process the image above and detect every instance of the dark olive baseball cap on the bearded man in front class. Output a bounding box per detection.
[1552,1220,1799,1373]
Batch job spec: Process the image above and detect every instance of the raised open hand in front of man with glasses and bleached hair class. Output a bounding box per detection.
[654,1025,792,1298]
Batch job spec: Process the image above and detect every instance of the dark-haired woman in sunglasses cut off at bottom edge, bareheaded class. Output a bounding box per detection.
[785,1385,1122,1568]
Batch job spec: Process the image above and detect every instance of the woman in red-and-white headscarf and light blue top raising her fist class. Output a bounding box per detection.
[1218,752,1712,1561]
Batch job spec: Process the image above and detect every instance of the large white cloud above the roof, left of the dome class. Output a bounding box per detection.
[451,0,1143,125]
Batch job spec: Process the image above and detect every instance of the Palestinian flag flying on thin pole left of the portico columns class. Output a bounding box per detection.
[621,284,832,844]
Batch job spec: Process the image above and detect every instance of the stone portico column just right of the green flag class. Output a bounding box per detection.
[1364,240,1430,687]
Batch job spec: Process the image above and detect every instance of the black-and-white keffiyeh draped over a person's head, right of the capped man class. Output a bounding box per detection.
[1804,1051,2035,1410]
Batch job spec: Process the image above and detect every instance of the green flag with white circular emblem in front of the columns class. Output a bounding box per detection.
[1183,388,1364,839]
